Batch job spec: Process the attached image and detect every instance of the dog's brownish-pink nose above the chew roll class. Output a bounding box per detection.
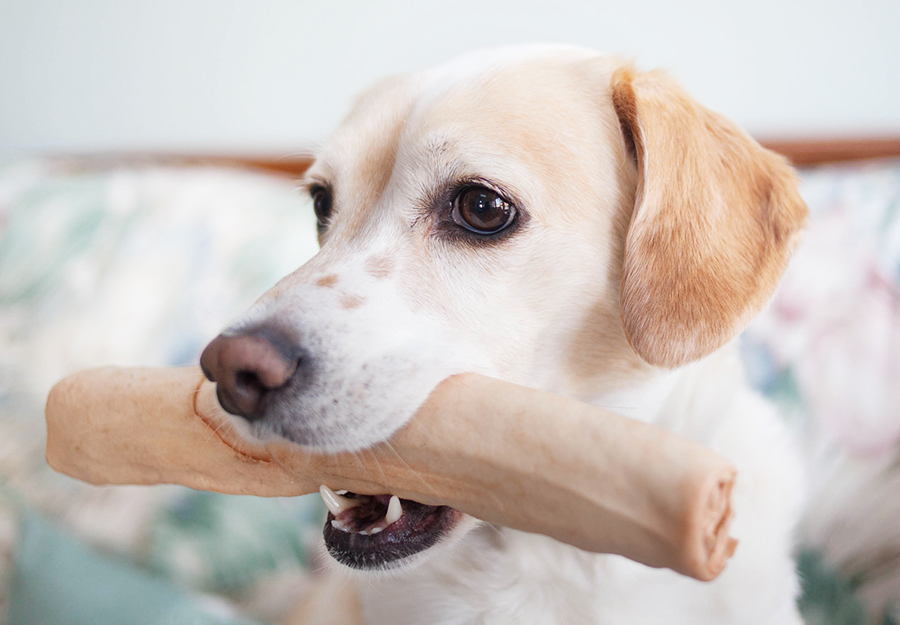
[200,326,300,421]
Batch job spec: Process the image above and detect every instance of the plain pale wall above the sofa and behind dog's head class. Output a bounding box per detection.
[0,0,900,156]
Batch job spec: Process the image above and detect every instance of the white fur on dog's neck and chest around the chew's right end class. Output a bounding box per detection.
[360,349,804,625]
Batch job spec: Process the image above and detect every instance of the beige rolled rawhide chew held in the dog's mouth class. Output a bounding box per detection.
[47,367,737,580]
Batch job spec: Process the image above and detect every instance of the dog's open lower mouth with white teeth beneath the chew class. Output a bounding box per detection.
[319,485,462,570]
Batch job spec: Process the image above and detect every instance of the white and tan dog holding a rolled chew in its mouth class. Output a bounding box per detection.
[201,46,807,625]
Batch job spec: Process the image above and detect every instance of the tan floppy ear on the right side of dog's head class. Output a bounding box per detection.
[612,68,807,367]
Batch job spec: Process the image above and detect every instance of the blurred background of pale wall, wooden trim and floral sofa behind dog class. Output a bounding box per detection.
[0,0,900,625]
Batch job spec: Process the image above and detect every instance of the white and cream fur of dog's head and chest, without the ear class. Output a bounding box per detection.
[221,48,804,625]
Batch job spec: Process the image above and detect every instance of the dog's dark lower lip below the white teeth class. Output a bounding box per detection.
[322,499,462,571]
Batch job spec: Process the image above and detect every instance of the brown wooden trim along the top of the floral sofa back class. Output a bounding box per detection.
[63,137,900,178]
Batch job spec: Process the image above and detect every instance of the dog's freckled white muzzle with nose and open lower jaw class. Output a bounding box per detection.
[201,247,478,570]
